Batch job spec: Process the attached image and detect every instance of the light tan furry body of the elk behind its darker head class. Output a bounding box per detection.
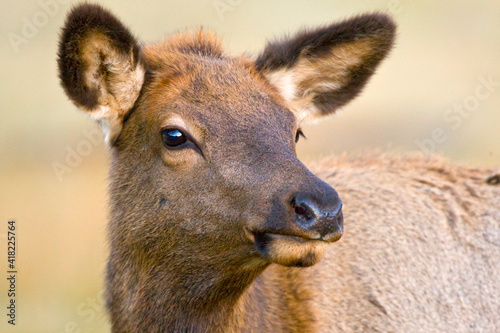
[236,153,500,332]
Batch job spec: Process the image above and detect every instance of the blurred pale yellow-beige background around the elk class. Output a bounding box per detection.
[0,0,500,332]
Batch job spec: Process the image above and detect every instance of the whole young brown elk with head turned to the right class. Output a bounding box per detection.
[58,3,500,332]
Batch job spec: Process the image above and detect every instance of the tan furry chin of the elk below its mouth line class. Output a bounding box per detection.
[249,233,329,267]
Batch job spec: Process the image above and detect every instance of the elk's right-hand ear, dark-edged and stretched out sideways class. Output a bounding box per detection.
[255,14,396,120]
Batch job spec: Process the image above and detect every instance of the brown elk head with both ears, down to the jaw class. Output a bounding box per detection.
[58,4,395,271]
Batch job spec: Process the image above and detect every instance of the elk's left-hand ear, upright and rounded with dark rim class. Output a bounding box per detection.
[57,3,144,144]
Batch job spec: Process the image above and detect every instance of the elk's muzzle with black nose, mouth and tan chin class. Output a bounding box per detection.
[246,179,343,267]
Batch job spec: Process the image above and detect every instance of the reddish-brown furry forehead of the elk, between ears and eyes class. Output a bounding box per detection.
[141,34,297,149]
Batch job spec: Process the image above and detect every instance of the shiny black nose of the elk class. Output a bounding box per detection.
[290,189,344,242]
